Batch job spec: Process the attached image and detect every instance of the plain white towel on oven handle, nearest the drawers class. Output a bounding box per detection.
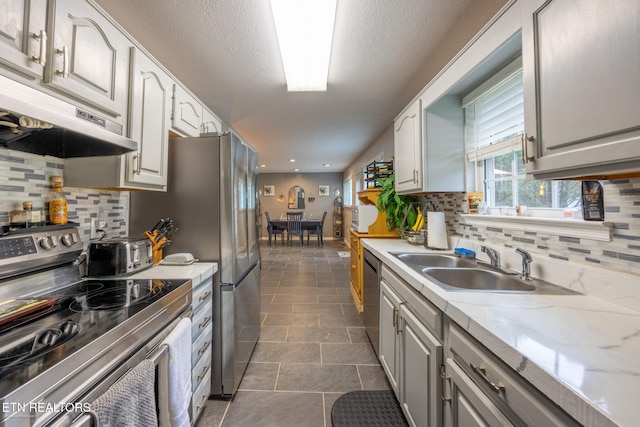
[164,317,191,427]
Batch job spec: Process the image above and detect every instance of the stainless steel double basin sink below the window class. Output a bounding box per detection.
[392,253,577,295]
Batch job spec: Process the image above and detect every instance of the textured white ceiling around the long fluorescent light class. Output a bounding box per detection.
[96,0,496,172]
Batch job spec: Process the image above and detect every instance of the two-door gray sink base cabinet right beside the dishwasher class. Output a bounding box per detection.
[379,267,443,427]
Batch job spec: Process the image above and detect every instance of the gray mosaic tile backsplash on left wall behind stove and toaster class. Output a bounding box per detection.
[0,148,129,243]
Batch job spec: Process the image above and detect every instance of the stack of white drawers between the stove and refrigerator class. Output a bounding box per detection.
[191,276,213,423]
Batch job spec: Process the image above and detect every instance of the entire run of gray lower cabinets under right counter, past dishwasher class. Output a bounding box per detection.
[378,265,580,427]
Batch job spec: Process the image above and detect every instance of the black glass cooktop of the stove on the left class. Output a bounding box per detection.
[0,279,186,396]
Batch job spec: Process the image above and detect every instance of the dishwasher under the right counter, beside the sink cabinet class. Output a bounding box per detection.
[362,248,382,356]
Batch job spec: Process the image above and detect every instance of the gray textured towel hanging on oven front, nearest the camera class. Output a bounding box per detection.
[91,360,158,427]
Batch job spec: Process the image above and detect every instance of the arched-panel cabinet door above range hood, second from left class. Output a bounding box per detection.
[45,0,132,120]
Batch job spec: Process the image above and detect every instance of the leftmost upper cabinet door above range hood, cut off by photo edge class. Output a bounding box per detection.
[0,0,47,79]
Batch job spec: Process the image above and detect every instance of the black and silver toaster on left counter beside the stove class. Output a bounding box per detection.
[87,237,153,276]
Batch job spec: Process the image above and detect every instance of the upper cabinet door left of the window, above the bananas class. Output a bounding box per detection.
[393,99,422,193]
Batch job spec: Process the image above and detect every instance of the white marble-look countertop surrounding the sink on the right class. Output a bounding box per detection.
[362,239,640,427]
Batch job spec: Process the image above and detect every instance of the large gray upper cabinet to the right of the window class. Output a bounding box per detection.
[522,0,640,179]
